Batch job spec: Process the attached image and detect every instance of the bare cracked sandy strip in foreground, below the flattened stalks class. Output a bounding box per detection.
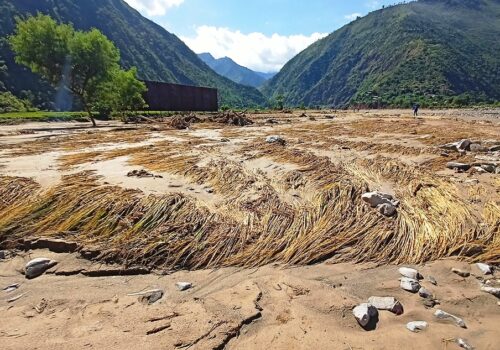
[0,250,500,350]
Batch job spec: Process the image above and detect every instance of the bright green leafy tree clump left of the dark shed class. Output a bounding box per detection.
[9,14,146,126]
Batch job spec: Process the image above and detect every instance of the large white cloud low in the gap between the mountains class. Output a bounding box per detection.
[181,26,327,72]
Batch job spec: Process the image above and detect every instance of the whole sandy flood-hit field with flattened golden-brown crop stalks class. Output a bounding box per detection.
[0,110,500,349]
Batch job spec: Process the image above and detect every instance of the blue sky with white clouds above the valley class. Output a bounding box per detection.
[125,0,395,72]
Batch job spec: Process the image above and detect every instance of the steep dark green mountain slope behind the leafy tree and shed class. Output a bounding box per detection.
[0,0,265,106]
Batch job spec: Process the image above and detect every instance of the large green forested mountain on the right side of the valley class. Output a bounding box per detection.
[262,0,500,107]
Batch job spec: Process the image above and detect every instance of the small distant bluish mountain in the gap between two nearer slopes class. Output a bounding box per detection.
[198,53,275,88]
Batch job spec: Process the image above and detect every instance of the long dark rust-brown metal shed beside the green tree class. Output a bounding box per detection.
[144,81,219,112]
